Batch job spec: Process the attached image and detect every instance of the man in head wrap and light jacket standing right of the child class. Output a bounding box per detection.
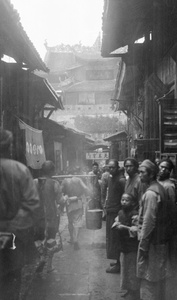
[137,159,171,300]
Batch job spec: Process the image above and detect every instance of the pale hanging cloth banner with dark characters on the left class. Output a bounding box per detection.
[19,120,46,169]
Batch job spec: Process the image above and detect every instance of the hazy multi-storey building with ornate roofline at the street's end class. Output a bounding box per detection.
[45,46,125,139]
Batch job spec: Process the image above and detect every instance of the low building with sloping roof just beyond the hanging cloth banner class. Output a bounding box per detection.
[39,118,93,174]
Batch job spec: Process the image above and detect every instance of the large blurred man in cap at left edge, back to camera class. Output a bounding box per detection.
[0,129,39,300]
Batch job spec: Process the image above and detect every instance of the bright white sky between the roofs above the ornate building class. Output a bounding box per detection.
[11,0,103,58]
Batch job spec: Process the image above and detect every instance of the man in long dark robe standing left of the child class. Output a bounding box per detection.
[102,159,125,273]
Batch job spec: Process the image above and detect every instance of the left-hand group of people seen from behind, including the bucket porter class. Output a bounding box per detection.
[0,129,101,300]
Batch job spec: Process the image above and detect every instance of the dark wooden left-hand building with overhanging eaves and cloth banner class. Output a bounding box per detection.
[0,0,63,170]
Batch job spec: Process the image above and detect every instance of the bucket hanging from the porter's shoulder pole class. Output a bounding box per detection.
[86,209,103,230]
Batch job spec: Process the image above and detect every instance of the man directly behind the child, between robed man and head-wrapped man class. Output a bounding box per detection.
[124,157,147,209]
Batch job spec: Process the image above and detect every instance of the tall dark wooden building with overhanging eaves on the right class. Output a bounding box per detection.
[102,0,177,162]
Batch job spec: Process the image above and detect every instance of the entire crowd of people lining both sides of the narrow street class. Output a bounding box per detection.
[0,129,177,300]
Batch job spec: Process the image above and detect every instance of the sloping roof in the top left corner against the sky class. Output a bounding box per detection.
[0,0,48,72]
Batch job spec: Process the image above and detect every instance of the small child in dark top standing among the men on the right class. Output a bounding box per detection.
[113,194,139,300]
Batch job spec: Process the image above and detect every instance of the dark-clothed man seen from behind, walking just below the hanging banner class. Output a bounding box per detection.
[34,160,64,273]
